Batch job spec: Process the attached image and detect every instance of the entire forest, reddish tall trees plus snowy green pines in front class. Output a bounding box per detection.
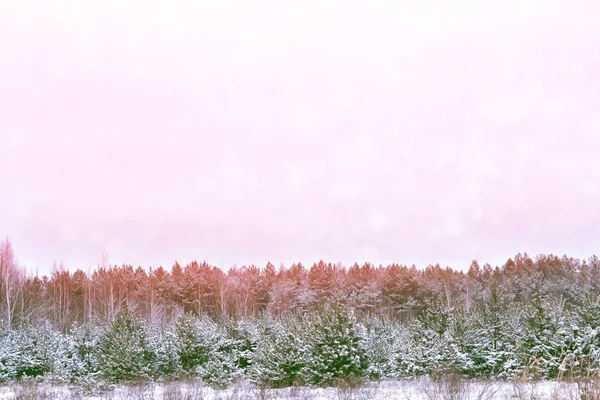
[0,240,600,394]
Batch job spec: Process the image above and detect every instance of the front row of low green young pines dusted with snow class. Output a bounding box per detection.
[0,293,600,390]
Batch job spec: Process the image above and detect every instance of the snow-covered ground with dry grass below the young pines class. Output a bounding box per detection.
[0,378,600,400]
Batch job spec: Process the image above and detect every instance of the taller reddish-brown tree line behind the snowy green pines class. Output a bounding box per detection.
[0,239,600,332]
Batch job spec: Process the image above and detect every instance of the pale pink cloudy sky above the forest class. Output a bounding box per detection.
[0,0,600,272]
